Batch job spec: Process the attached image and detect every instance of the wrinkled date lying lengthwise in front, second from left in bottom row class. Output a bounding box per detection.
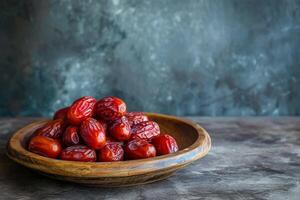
[60,145,97,162]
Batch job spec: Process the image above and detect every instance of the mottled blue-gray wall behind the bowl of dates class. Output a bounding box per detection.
[0,0,300,116]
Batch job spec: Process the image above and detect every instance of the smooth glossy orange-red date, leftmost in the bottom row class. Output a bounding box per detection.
[28,135,62,158]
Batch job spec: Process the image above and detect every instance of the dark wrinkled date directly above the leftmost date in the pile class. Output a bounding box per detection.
[34,119,65,139]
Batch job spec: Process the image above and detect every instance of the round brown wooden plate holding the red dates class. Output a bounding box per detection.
[7,113,211,187]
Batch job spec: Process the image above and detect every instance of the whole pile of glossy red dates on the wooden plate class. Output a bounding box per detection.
[28,96,178,162]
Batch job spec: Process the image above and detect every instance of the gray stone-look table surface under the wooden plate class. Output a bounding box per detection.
[0,117,300,200]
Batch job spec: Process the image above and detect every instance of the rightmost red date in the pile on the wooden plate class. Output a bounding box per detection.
[151,135,178,155]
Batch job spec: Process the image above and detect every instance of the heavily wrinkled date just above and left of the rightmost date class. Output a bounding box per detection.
[131,121,160,140]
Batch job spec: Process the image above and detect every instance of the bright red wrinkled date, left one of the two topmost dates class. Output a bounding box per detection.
[67,96,97,126]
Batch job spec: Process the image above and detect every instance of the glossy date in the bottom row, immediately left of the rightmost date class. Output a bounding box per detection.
[124,139,156,160]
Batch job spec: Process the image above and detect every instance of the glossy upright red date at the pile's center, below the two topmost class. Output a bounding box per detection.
[80,118,106,150]
